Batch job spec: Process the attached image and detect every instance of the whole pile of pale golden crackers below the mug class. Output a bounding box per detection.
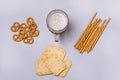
[35,44,72,77]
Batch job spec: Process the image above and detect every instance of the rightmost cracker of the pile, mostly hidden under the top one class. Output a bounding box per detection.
[59,58,72,77]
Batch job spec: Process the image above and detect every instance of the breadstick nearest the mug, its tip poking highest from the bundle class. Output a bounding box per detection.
[74,12,97,48]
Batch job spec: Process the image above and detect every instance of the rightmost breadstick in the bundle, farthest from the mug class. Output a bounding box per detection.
[89,18,111,52]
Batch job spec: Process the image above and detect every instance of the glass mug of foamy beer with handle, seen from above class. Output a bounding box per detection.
[46,9,69,42]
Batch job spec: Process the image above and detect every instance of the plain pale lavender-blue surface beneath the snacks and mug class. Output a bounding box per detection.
[0,0,120,80]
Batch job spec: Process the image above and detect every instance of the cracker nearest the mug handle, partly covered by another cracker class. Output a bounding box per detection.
[43,44,66,60]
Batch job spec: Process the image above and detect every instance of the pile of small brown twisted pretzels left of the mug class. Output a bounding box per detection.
[11,17,40,44]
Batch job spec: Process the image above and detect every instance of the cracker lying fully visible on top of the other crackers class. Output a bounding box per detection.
[45,55,65,75]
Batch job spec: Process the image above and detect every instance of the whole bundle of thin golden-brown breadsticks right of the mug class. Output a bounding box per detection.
[74,12,111,53]
